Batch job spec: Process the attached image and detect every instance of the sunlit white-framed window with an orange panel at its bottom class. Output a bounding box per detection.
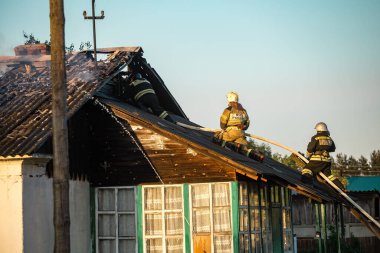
[190,183,233,253]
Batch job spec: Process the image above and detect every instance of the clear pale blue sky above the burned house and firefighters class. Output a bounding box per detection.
[0,0,380,158]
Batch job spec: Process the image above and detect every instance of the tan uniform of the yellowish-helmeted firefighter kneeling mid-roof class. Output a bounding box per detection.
[220,102,250,145]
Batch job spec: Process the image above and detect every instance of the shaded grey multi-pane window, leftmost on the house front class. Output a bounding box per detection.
[95,187,137,253]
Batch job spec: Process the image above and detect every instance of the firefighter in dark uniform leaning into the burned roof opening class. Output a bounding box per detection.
[128,73,175,123]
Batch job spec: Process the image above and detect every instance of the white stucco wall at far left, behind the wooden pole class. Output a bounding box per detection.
[0,158,91,253]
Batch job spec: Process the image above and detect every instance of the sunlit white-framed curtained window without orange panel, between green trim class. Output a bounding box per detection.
[143,186,185,253]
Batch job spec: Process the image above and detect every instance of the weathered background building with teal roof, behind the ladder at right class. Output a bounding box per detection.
[292,176,380,253]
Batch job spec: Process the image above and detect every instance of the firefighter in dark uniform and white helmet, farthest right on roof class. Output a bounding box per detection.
[302,122,344,190]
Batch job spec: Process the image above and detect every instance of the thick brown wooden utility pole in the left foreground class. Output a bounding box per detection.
[50,0,70,253]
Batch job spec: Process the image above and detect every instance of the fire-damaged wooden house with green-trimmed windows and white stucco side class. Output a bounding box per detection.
[0,47,376,253]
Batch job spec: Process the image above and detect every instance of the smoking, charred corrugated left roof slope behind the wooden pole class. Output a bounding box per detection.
[0,47,142,157]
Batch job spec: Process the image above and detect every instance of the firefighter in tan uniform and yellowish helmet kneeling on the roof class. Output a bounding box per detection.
[213,92,264,162]
